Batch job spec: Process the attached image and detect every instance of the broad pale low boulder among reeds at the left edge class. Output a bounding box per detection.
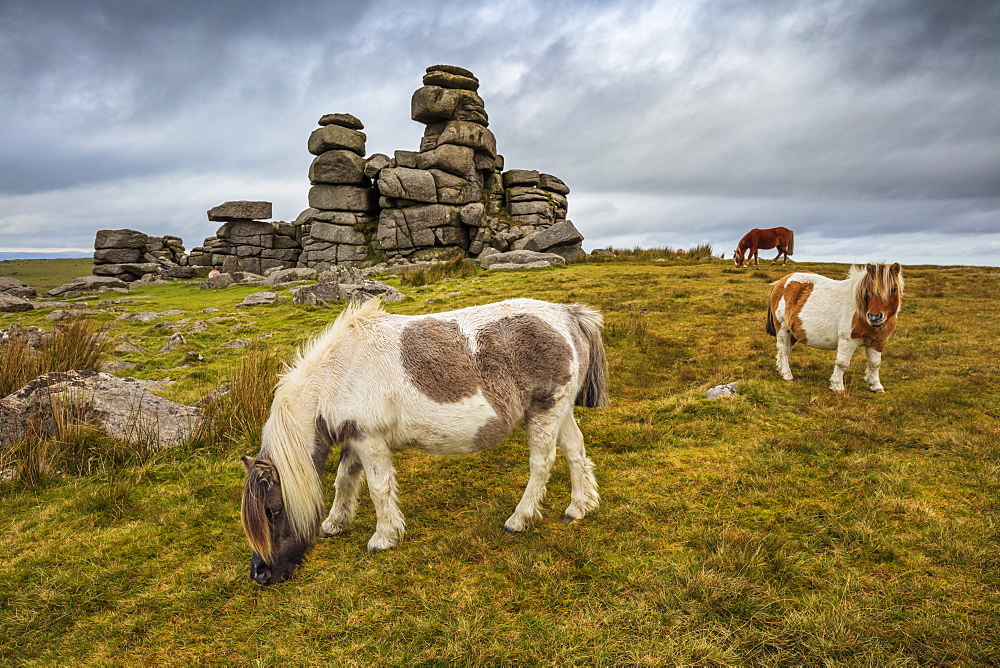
[0,371,198,448]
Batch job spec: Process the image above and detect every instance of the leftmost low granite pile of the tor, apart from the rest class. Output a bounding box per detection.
[93,229,187,282]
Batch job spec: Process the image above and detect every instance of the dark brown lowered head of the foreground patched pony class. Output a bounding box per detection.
[240,457,315,584]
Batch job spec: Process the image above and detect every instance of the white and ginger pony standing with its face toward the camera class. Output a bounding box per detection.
[767,263,903,392]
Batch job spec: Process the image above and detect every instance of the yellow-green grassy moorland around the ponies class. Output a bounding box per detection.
[0,256,1000,665]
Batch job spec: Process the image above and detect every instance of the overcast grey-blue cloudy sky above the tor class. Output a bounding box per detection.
[0,0,1000,266]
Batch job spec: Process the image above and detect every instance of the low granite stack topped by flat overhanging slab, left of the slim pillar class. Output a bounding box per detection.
[188,200,302,274]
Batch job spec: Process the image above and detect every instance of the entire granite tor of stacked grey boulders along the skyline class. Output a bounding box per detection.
[136,65,584,272]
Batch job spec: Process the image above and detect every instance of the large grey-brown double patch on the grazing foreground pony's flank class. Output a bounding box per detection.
[401,315,573,448]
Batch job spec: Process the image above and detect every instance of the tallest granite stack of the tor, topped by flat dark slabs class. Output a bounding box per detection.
[377,65,503,260]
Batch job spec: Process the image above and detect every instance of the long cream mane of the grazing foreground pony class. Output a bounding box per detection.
[260,299,385,540]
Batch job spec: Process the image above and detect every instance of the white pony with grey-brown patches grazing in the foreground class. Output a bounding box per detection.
[241,299,607,584]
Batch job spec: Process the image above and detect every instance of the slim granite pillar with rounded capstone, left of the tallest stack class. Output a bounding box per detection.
[295,114,378,270]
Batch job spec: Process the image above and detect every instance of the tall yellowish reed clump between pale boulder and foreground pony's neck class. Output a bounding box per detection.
[198,339,282,447]
